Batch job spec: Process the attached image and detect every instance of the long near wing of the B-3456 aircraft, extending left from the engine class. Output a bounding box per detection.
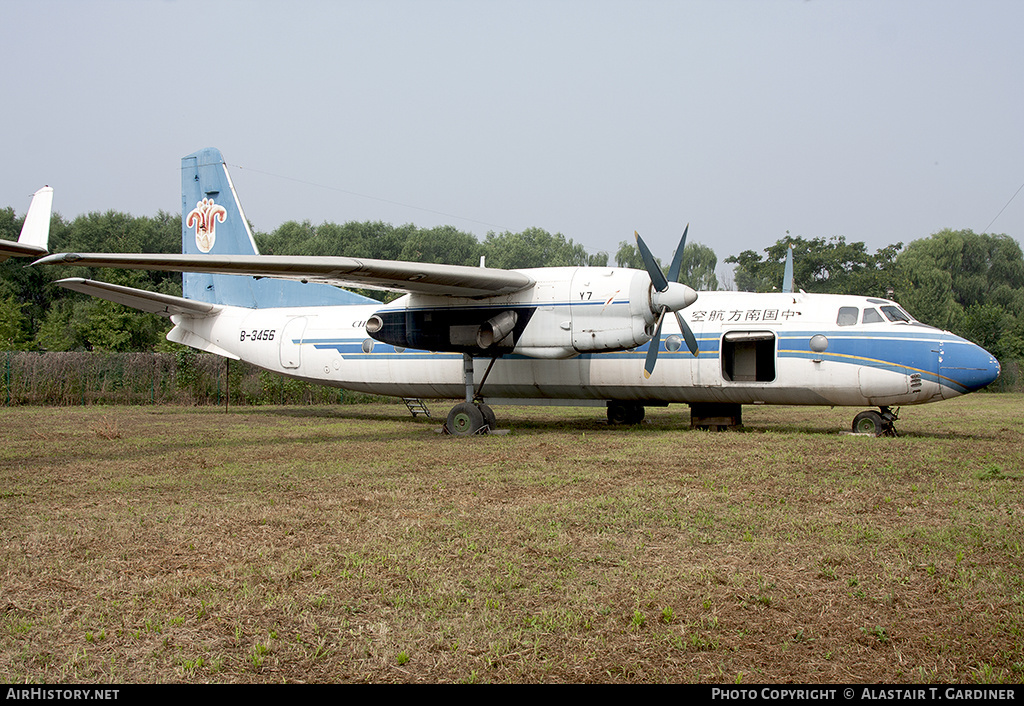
[33,253,534,298]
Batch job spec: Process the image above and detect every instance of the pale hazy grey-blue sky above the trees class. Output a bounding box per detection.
[0,0,1024,274]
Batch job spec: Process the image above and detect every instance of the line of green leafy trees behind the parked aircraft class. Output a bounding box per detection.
[0,208,1024,385]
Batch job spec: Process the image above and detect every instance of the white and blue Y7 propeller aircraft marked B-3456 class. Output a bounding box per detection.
[37,150,999,435]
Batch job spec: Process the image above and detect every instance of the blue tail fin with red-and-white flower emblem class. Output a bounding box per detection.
[181,148,376,308]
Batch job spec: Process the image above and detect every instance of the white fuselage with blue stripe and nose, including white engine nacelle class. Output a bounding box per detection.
[168,267,998,406]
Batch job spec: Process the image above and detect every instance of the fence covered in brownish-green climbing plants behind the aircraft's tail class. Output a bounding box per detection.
[0,350,387,406]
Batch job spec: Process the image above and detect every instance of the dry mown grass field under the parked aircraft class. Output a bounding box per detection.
[0,393,1024,683]
